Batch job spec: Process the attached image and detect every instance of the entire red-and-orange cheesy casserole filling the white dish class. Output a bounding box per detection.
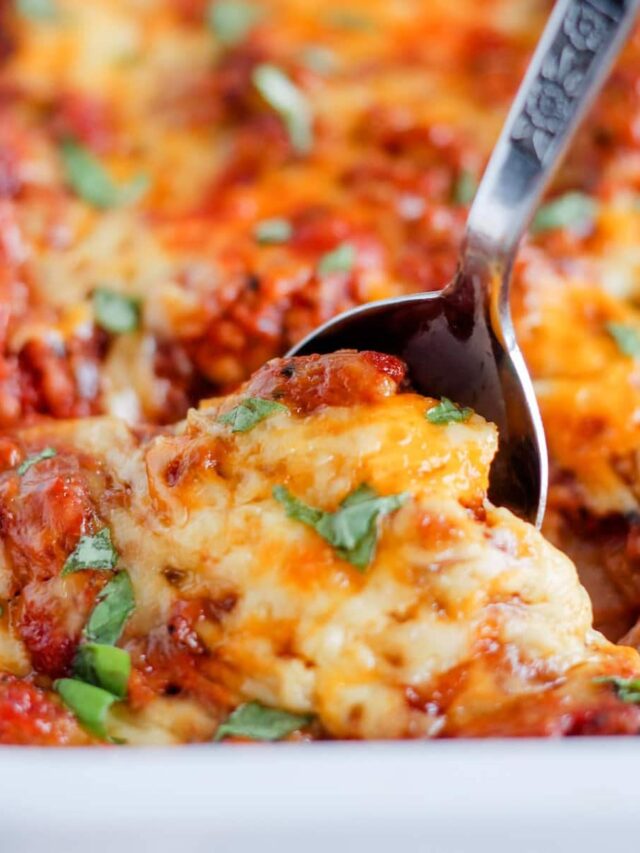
[0,0,640,745]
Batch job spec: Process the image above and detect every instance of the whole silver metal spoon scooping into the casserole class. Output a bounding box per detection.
[288,0,640,526]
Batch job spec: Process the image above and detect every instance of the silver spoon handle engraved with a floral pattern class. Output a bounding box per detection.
[466,0,640,265]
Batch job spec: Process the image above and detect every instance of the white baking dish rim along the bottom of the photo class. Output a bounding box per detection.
[0,738,640,853]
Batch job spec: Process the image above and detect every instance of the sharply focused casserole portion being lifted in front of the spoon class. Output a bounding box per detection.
[0,352,640,743]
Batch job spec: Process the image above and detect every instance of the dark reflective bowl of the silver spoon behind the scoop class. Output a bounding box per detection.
[292,262,547,524]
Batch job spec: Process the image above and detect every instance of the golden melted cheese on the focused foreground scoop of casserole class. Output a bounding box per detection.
[5,356,640,742]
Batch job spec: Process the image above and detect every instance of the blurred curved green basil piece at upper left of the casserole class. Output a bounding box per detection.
[60,139,149,208]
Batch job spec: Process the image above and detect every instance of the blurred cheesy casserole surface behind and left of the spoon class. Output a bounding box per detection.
[0,0,544,422]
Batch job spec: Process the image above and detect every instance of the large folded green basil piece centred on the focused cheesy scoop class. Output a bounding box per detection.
[273,483,409,570]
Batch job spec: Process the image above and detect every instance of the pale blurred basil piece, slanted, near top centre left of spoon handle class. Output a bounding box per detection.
[253,63,313,154]
